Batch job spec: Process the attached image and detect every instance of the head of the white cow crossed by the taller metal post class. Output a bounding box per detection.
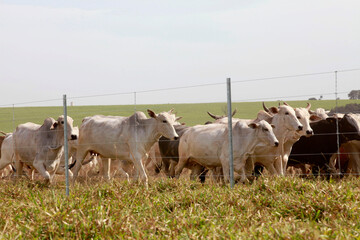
[248,120,279,147]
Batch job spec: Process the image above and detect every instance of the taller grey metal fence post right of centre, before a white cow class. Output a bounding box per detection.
[226,78,234,188]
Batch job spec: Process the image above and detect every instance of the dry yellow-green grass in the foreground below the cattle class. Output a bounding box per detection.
[0,177,360,239]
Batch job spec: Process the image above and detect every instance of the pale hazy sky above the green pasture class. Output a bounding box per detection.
[0,0,360,107]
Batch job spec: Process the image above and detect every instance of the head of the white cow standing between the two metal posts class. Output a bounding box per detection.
[147,109,179,140]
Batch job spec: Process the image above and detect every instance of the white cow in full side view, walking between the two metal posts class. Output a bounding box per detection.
[73,110,178,184]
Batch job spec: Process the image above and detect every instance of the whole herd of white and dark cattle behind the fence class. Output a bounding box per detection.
[0,102,360,184]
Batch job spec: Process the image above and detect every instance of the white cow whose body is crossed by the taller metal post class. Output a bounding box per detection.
[175,120,279,182]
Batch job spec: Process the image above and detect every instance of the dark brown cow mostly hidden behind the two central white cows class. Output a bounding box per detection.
[159,125,208,183]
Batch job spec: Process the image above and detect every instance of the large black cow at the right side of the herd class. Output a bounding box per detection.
[287,114,360,174]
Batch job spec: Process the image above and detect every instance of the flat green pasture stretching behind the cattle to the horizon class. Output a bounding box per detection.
[0,100,359,132]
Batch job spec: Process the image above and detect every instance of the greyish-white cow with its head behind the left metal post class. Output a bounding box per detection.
[13,116,77,182]
